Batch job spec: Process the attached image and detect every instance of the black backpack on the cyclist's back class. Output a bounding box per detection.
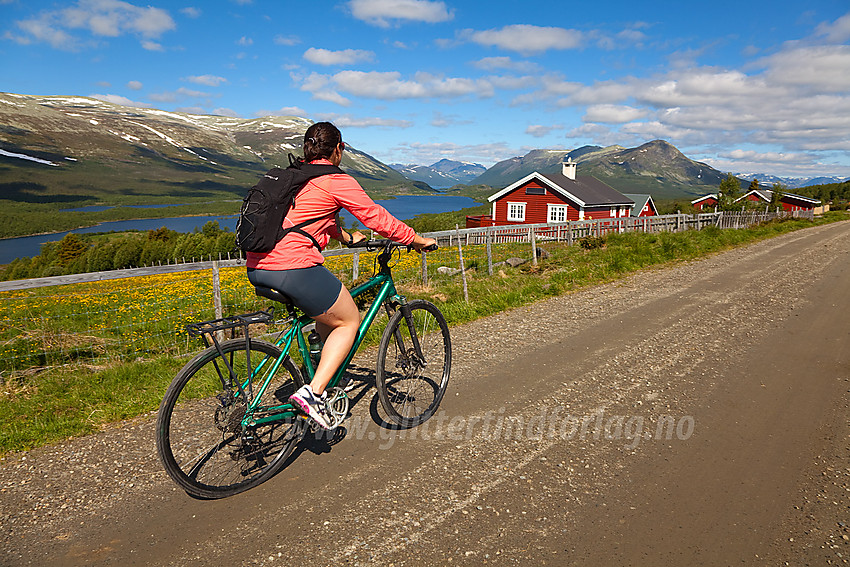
[236,154,344,252]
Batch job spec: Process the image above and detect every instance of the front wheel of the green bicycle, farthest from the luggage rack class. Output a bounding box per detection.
[376,299,452,427]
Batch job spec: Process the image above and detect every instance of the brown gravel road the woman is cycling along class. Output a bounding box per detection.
[0,222,850,566]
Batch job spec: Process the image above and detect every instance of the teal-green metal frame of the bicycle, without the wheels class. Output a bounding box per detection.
[240,246,410,427]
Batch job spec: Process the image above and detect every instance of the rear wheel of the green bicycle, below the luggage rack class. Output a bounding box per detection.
[156,339,306,498]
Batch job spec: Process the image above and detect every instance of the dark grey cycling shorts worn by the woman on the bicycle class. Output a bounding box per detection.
[248,264,342,317]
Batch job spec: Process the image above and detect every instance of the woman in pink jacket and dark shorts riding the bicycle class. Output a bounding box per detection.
[247,122,436,429]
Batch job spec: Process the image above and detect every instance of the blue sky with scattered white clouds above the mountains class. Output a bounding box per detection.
[0,0,850,176]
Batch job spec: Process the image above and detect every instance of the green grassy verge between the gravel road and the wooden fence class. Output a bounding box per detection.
[0,213,847,454]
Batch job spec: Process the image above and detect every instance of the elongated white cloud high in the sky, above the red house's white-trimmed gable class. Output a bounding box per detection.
[466,24,584,54]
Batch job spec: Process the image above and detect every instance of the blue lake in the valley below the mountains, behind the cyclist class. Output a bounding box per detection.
[0,195,478,264]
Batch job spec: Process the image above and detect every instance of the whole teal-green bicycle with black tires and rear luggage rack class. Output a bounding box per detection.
[156,240,451,498]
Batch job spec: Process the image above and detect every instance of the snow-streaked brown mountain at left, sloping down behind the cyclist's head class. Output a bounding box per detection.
[0,93,430,210]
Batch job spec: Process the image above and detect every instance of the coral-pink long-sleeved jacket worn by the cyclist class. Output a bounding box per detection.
[246,159,416,270]
